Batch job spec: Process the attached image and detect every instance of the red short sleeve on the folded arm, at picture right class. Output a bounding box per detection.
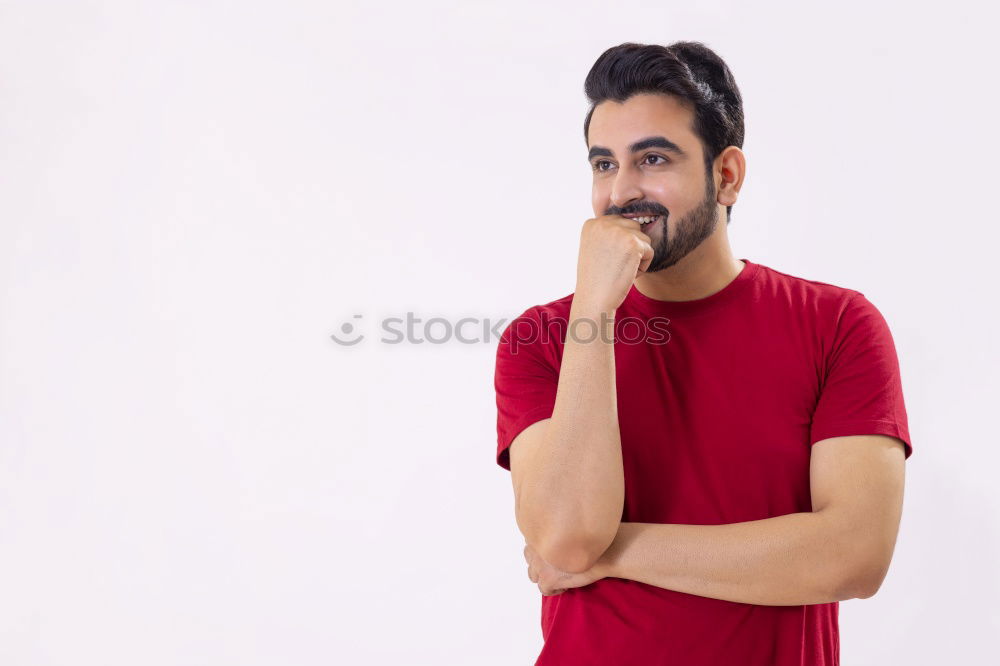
[809,292,913,458]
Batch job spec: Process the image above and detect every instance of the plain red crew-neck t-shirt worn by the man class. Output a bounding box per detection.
[495,259,912,666]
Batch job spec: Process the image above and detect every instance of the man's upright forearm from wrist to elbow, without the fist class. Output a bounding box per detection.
[520,301,625,571]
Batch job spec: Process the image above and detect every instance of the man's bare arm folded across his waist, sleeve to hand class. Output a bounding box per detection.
[526,435,904,606]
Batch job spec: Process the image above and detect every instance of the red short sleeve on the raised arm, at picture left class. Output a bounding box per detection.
[494,309,559,471]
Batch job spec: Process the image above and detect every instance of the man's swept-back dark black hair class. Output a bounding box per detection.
[583,42,743,224]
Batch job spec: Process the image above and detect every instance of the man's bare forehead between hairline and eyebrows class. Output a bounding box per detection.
[587,93,698,154]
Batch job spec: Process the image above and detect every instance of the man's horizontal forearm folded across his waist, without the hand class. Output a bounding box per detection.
[598,511,859,606]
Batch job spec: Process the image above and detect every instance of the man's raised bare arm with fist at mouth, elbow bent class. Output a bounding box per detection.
[510,215,653,571]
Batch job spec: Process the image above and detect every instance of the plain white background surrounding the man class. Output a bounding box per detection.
[0,1,1000,666]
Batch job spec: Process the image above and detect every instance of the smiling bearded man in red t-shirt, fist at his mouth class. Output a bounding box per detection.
[495,42,912,666]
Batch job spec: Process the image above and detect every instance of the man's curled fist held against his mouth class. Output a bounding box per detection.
[573,215,653,312]
